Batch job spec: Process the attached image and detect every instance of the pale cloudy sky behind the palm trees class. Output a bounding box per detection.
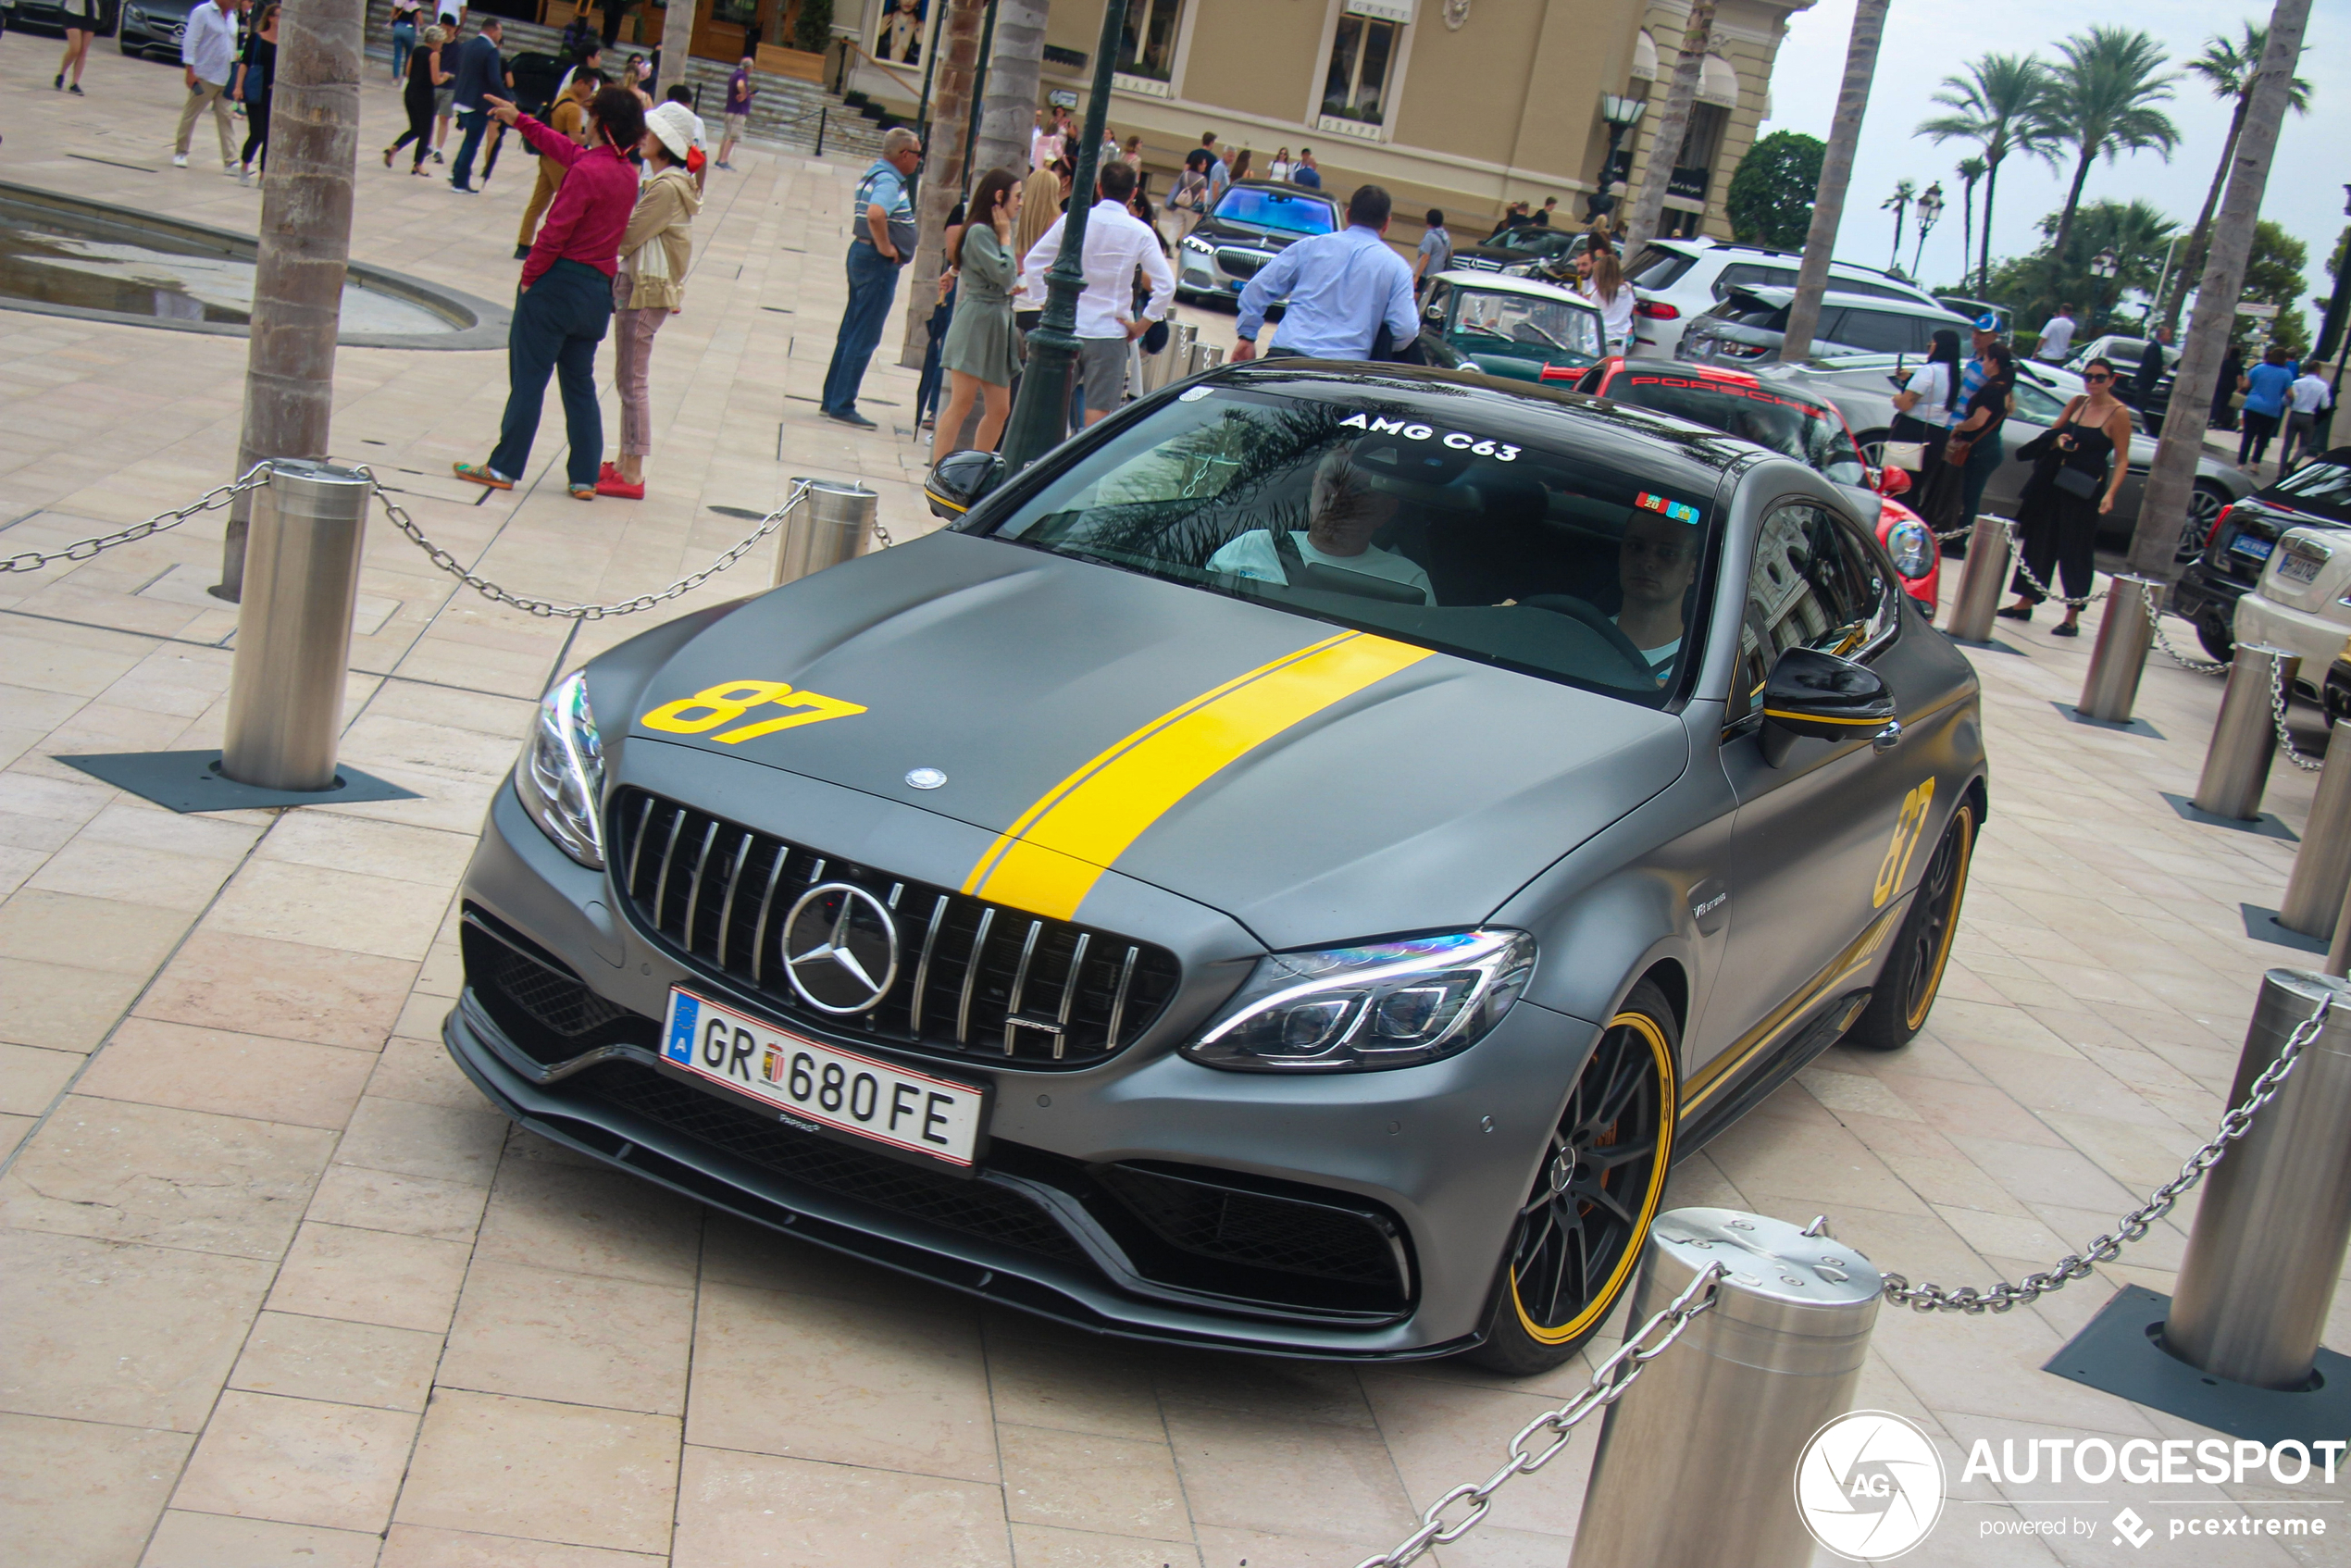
[1763,0,2351,315]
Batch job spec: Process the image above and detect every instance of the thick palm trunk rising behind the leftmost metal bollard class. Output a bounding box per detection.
[214,0,365,602]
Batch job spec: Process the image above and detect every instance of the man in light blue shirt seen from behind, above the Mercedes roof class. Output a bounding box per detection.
[1232,186,1420,365]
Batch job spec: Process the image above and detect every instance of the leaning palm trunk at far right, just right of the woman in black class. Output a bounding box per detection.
[2130,0,2311,583]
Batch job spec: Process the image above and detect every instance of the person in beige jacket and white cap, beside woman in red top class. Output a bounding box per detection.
[595,104,703,501]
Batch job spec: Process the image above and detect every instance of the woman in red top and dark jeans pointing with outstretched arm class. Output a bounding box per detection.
[456,87,647,501]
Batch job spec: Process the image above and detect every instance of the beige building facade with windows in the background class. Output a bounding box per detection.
[837,0,1812,240]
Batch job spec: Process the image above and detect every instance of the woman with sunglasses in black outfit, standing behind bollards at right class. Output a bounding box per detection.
[2001,360,2130,637]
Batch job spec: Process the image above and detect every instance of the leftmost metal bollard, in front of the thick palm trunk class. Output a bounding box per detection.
[221,458,374,790]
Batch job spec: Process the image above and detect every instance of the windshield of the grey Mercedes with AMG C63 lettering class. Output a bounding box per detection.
[994,383,1716,707]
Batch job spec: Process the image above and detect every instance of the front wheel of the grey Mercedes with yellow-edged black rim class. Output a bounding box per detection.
[1467,980,1681,1377]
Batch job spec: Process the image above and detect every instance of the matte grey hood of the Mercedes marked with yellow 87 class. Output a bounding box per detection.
[620,534,1688,948]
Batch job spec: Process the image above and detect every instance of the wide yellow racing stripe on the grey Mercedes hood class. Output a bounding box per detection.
[964,632,1429,919]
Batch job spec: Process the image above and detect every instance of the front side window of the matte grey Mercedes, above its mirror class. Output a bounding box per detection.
[1728,501,1897,719]
